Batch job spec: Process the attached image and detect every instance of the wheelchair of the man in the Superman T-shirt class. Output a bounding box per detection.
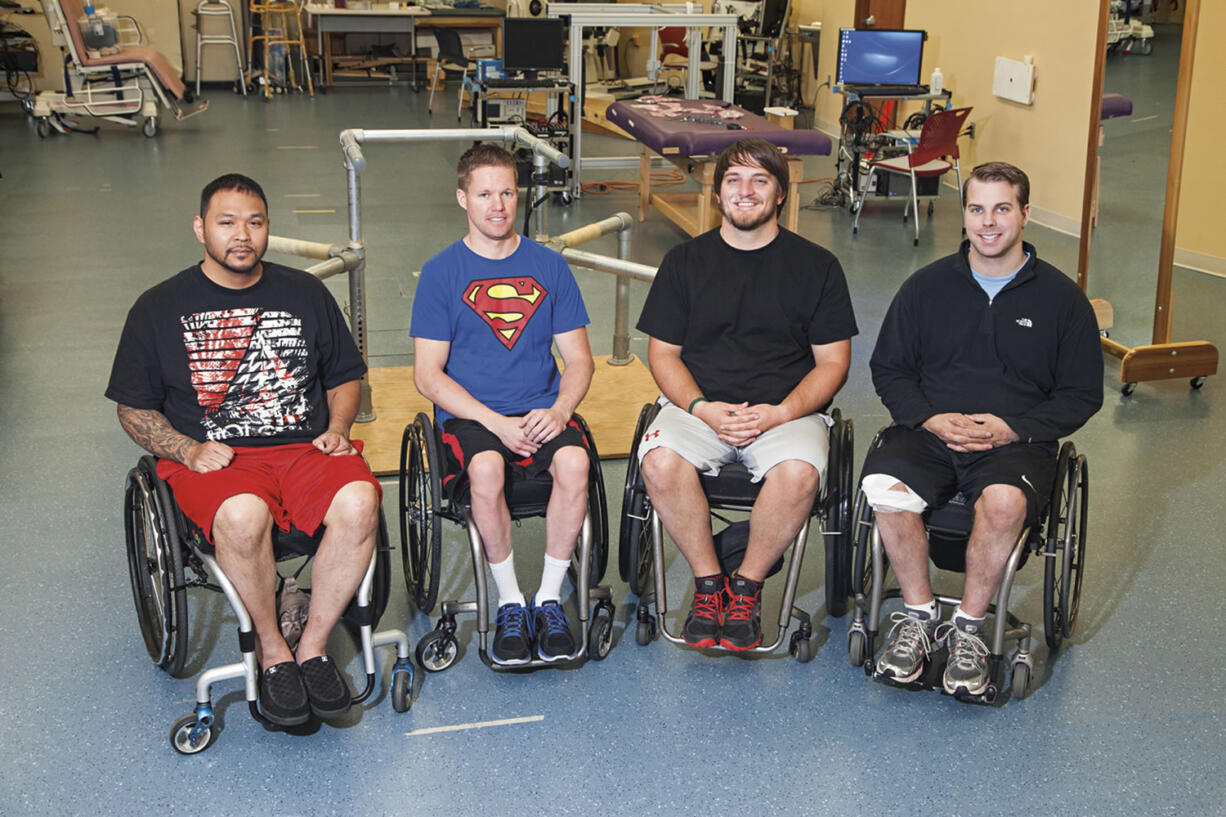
[400,413,613,672]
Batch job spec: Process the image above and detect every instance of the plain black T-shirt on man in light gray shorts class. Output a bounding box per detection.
[638,229,859,404]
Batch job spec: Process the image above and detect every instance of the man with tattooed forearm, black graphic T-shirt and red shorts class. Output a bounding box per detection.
[107,174,383,726]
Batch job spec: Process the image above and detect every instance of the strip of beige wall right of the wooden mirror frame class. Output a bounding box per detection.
[1176,0,1226,271]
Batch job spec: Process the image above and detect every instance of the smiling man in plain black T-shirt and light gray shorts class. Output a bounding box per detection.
[638,139,857,650]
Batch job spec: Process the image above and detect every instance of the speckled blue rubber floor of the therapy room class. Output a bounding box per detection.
[0,22,1226,817]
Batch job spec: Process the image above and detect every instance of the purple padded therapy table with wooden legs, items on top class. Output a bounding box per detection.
[604,97,831,236]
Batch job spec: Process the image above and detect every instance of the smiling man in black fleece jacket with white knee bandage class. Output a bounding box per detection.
[862,162,1102,696]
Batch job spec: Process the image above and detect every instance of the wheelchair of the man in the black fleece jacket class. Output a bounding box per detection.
[847,432,1090,704]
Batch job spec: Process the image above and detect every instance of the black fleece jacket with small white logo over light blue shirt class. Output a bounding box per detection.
[870,240,1102,443]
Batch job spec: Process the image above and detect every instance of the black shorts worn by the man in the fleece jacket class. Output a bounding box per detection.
[861,426,1058,524]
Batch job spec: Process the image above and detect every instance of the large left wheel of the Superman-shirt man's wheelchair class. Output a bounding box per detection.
[400,413,443,613]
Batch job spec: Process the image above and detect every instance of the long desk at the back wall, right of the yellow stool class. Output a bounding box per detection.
[303,2,505,91]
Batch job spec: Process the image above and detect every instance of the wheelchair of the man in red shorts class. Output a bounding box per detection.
[124,455,413,754]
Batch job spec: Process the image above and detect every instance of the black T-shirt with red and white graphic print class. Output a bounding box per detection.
[107,261,367,445]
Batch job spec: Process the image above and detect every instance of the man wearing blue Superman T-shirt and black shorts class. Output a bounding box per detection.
[409,145,595,665]
